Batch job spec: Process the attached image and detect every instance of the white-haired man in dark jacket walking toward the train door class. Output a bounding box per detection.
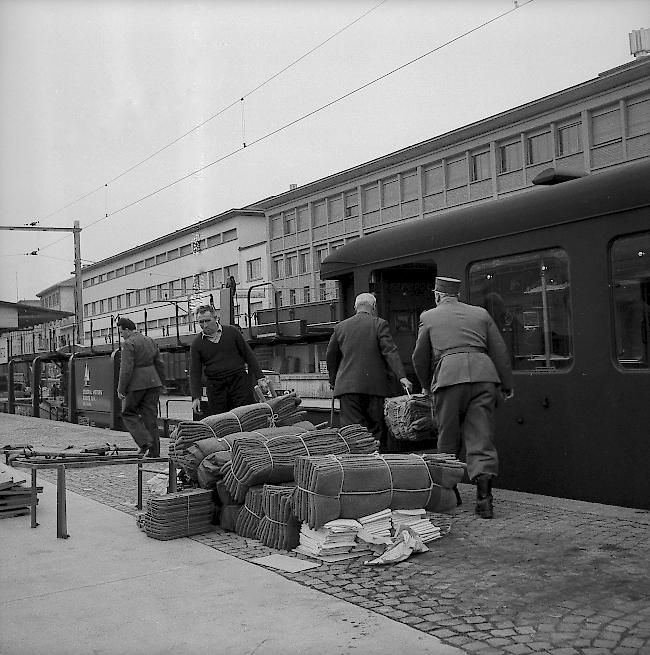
[326,293,412,449]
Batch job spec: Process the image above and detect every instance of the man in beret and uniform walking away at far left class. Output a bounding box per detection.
[117,316,165,457]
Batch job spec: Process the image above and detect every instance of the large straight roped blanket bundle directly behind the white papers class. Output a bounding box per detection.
[294,453,464,528]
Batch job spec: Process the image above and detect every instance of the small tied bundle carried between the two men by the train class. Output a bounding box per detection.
[384,393,438,441]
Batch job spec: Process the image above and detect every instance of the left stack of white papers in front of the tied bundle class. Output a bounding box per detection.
[295,519,370,562]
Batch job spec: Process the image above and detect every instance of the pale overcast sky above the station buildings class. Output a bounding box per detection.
[0,0,650,302]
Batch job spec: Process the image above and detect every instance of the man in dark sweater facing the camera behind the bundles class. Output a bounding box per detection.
[190,305,268,415]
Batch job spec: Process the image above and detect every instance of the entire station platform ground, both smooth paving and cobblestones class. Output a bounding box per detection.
[0,414,650,655]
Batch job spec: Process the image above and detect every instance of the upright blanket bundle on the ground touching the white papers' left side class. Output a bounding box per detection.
[257,484,300,550]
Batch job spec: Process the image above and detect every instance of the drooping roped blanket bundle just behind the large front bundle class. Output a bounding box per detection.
[223,425,377,502]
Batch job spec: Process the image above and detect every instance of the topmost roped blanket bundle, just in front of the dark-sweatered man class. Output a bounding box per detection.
[169,393,307,479]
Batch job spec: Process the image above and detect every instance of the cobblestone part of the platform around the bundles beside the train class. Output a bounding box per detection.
[0,415,650,655]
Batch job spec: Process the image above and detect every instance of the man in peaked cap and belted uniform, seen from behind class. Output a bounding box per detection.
[412,277,513,519]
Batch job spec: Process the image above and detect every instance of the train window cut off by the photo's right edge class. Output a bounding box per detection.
[611,232,650,368]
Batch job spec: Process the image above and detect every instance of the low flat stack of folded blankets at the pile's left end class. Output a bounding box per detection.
[144,489,214,540]
